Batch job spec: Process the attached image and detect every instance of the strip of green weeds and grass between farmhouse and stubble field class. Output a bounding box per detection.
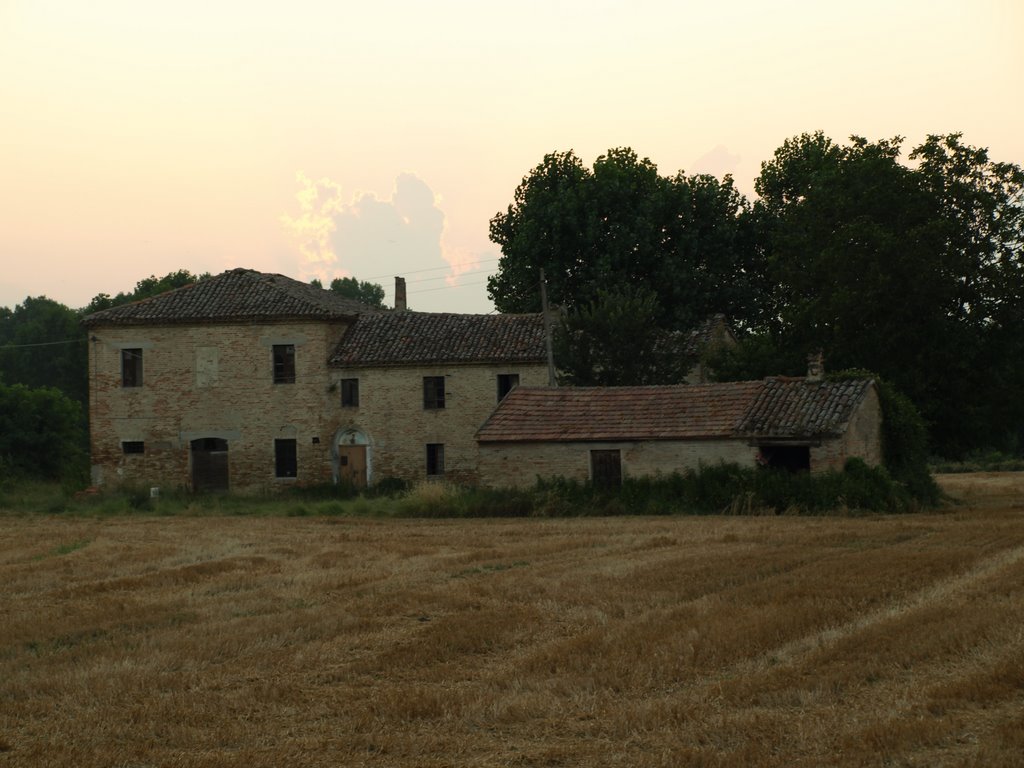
[0,459,931,518]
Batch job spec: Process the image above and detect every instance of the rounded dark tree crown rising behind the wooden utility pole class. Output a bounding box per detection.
[487,148,759,331]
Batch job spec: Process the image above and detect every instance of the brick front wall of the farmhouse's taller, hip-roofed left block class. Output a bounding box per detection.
[89,322,345,490]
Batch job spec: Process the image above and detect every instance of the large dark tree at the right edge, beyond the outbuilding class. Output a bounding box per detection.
[754,132,1024,456]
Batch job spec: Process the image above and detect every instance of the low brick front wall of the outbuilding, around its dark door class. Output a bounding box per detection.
[479,439,758,487]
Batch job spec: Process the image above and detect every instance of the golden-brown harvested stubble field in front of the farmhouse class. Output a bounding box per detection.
[0,475,1024,768]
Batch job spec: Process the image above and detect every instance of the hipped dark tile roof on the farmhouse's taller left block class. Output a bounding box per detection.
[83,269,377,326]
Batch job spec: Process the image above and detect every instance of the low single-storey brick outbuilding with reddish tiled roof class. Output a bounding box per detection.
[476,377,882,485]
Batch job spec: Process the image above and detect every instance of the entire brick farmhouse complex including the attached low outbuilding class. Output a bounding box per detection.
[83,269,881,492]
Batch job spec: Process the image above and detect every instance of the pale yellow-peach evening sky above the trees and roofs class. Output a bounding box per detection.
[0,0,1024,312]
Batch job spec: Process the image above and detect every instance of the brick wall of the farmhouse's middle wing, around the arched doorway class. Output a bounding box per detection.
[325,364,548,485]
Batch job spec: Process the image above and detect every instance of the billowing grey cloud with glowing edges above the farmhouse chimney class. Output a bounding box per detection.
[281,173,480,303]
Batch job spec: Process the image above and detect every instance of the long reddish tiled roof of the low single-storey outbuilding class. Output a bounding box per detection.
[476,379,872,442]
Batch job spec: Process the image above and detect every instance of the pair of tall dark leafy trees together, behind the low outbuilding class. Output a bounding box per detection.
[488,132,1024,456]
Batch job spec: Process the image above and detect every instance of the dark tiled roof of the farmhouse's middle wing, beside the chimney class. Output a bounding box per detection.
[331,311,546,367]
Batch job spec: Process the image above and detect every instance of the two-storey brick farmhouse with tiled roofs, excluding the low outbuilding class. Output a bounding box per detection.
[84,269,547,490]
